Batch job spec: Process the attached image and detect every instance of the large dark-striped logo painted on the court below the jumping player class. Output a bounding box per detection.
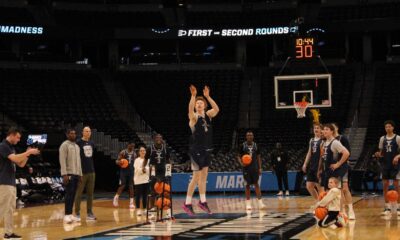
[70,212,315,240]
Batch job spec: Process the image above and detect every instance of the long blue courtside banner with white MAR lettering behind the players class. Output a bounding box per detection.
[172,171,297,192]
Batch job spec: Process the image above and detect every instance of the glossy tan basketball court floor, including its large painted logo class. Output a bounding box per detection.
[1,195,400,239]
